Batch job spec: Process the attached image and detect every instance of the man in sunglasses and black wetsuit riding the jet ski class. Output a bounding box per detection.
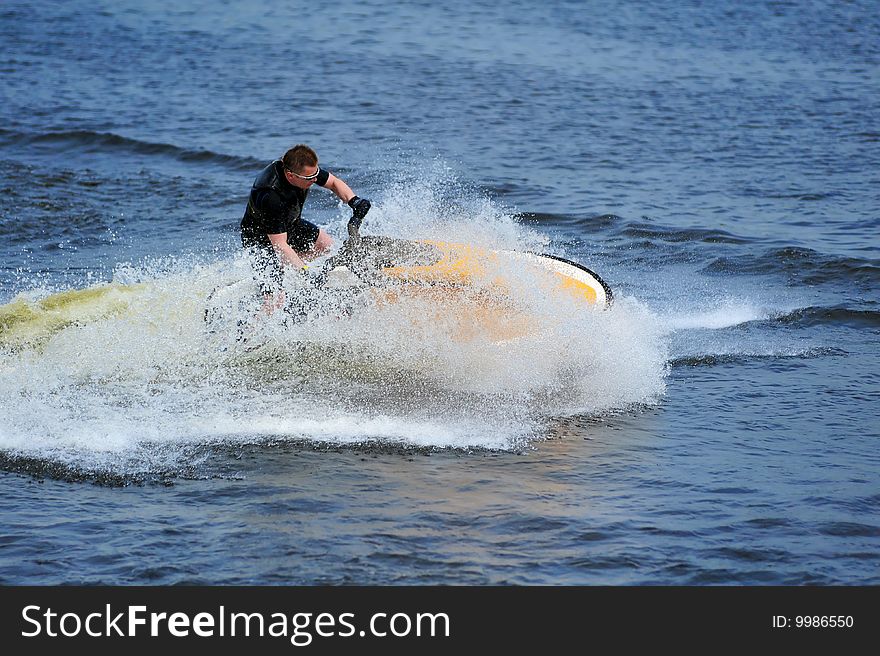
[241,144,370,313]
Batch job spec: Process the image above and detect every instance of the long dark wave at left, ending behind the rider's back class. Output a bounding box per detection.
[0,128,265,171]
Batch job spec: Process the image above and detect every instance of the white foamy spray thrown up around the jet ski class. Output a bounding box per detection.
[0,168,667,470]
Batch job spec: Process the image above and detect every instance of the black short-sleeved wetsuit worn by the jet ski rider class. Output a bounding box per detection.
[241,160,330,293]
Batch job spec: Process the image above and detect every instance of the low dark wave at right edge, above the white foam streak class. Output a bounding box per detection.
[703,246,880,286]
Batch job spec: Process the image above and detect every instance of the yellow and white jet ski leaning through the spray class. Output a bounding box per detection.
[205,218,613,344]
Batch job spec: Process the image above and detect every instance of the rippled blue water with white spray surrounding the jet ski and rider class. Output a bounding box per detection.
[0,0,880,585]
